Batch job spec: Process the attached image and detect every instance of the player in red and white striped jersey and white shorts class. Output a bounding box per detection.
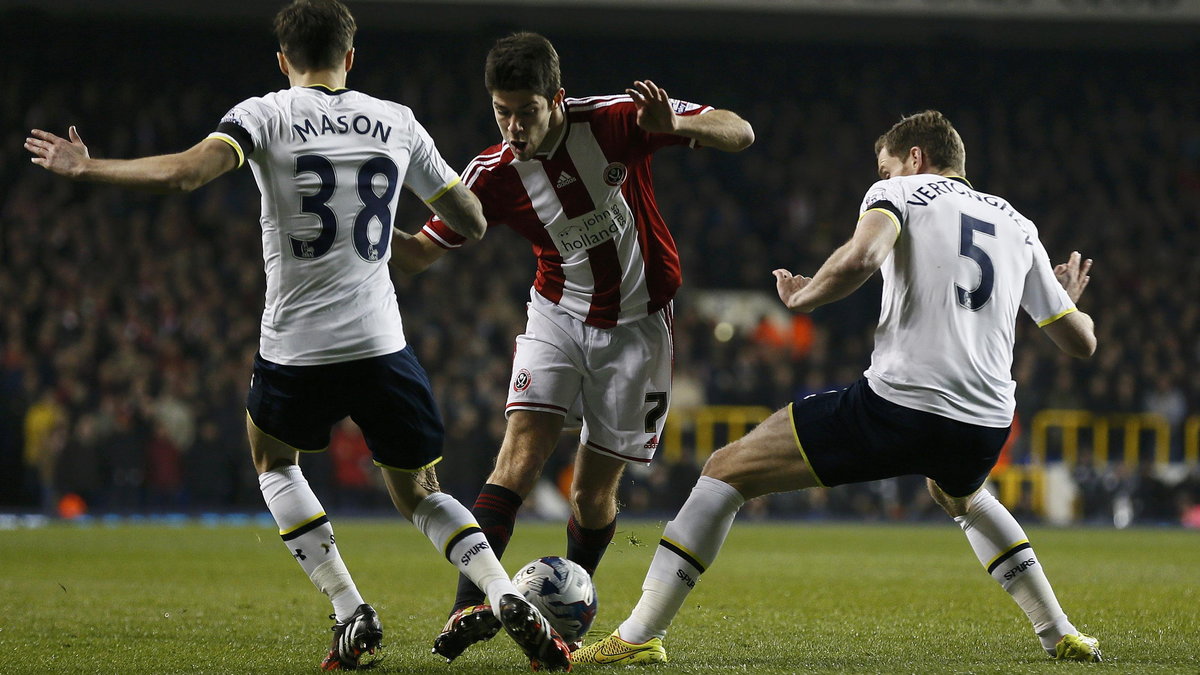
[397,32,754,659]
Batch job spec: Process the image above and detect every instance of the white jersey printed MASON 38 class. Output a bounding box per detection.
[209,86,458,365]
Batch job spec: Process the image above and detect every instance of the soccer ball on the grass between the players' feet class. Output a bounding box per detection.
[512,556,596,643]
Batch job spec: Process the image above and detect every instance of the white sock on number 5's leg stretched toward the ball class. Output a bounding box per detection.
[618,476,745,644]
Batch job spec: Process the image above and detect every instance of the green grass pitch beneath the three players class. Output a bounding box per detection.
[0,516,1200,675]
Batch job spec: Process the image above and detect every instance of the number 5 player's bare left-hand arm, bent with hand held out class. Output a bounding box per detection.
[773,211,898,312]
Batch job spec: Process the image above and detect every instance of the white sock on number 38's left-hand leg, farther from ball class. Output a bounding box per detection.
[258,465,364,621]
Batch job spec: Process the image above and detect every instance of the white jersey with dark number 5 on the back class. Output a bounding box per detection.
[860,174,1075,426]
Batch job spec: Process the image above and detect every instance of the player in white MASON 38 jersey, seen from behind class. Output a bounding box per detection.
[25,0,570,670]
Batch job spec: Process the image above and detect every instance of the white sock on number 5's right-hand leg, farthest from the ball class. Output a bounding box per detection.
[954,489,1076,655]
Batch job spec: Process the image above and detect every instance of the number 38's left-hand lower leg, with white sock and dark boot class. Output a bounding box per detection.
[246,416,383,670]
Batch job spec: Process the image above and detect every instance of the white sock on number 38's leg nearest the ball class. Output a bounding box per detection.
[413,492,521,616]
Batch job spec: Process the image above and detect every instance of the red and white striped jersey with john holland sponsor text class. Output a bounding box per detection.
[424,95,713,328]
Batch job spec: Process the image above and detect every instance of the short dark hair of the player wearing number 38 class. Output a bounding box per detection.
[275,0,358,72]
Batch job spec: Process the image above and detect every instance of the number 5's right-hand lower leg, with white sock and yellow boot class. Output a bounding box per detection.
[926,479,1100,661]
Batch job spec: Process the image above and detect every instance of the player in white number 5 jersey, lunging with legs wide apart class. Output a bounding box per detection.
[575,110,1100,664]
